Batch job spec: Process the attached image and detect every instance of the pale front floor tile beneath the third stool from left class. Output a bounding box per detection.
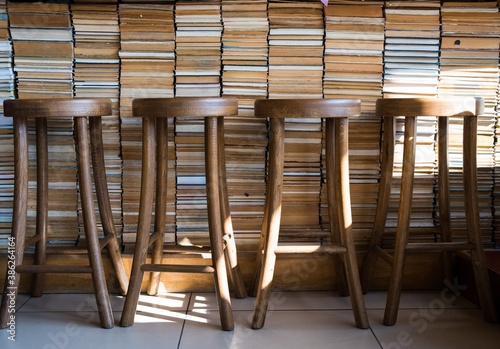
[180,310,380,349]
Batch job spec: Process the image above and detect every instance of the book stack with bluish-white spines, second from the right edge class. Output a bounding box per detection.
[382,0,440,241]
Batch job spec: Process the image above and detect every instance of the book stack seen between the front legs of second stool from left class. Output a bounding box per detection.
[175,0,222,244]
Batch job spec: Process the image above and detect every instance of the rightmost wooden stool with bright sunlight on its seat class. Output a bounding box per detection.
[361,98,497,326]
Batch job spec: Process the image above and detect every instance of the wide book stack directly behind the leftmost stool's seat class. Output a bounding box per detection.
[7,2,78,244]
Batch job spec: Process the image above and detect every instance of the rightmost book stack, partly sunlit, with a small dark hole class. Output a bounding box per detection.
[438,1,500,242]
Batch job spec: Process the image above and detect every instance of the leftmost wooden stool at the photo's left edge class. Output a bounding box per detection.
[0,98,128,328]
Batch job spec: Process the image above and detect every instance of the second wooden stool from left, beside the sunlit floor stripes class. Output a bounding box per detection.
[120,97,246,331]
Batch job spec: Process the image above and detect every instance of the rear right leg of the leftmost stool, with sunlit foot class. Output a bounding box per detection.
[89,117,128,295]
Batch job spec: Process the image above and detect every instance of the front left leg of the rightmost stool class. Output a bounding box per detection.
[383,117,417,326]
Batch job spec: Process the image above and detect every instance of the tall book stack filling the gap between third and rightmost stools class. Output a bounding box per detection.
[322,1,384,238]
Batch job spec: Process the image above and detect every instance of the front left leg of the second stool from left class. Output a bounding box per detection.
[120,118,156,327]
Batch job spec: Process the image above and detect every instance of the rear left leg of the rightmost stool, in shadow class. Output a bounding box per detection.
[360,118,396,293]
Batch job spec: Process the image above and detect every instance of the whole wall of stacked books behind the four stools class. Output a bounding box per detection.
[0,0,500,247]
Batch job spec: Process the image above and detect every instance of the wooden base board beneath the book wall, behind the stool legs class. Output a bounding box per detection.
[0,250,445,295]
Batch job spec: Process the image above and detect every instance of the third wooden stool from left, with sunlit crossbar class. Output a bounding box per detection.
[252,99,369,329]
